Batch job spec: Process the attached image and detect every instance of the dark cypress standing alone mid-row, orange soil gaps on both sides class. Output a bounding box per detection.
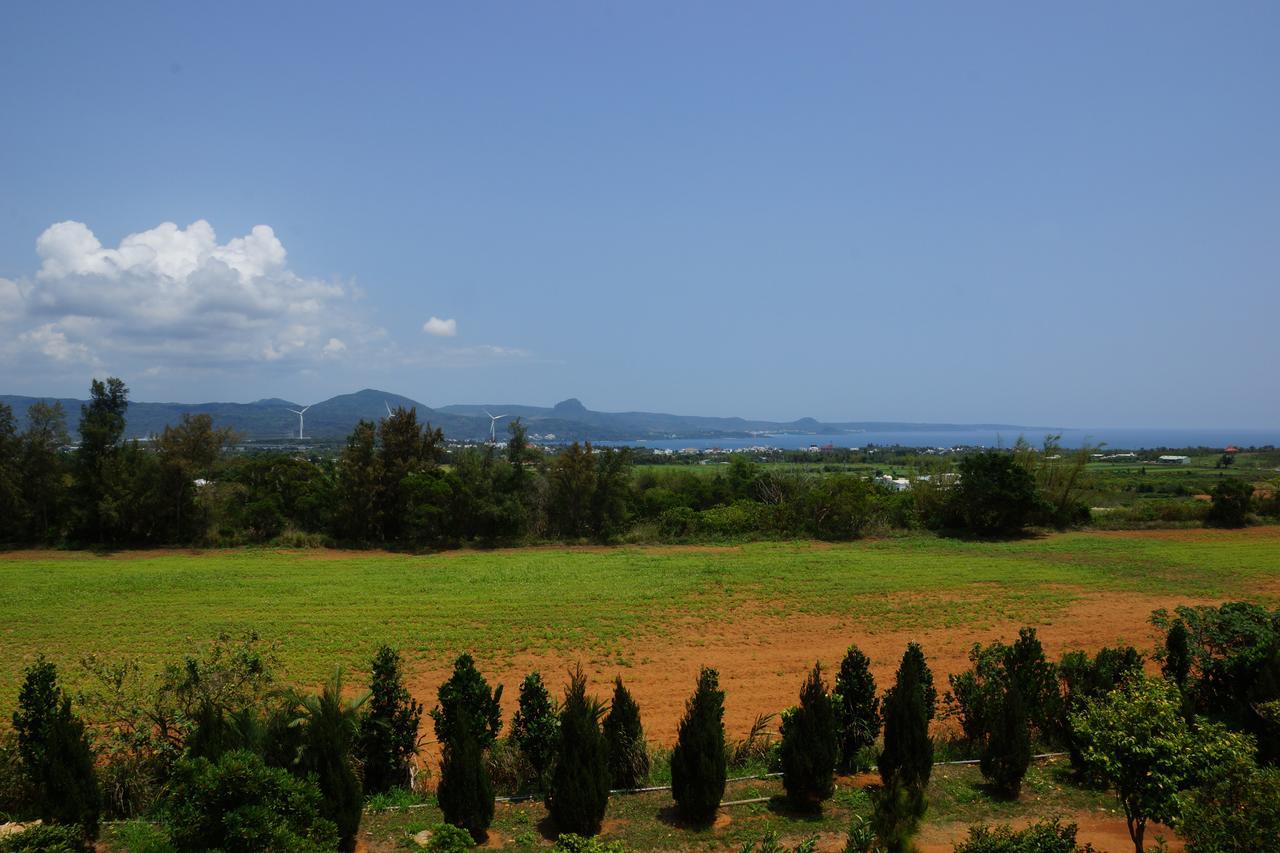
[671,666,728,824]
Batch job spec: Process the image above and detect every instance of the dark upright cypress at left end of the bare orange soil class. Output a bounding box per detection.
[358,646,422,794]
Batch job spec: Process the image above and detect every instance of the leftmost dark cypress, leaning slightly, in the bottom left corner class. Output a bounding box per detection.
[13,658,102,839]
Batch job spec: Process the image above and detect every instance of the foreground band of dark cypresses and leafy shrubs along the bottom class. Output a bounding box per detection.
[0,603,1280,853]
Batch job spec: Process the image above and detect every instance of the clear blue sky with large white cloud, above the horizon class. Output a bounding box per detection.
[0,1,1280,427]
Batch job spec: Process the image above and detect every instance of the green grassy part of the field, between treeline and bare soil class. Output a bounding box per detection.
[0,528,1280,711]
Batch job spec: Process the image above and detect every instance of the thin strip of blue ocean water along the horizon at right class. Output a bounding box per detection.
[598,427,1280,450]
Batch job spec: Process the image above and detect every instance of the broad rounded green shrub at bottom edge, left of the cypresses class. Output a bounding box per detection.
[165,752,338,853]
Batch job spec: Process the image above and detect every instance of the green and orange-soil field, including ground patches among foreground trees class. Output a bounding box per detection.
[10,528,1280,853]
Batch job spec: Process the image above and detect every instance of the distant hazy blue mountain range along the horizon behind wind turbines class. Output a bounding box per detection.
[0,388,1032,441]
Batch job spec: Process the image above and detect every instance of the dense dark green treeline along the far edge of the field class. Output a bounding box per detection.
[0,378,1280,548]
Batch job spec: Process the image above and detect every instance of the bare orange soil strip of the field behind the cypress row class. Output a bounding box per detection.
[410,590,1217,744]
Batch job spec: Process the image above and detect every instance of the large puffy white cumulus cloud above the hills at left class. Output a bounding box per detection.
[0,219,378,371]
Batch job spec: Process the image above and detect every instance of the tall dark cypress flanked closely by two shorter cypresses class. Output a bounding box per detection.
[547,666,609,835]
